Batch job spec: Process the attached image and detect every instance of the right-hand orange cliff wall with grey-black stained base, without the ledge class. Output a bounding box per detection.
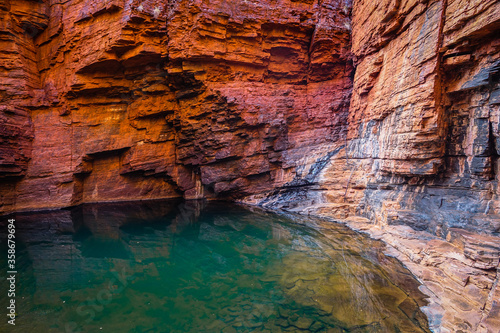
[347,0,500,234]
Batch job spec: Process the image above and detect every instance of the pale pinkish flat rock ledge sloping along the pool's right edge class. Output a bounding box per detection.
[332,218,500,332]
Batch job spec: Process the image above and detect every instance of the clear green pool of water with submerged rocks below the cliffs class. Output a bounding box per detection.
[0,201,429,332]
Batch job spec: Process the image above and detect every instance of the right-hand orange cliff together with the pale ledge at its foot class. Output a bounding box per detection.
[256,0,500,332]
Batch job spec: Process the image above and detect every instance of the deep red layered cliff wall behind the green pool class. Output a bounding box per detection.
[0,0,352,210]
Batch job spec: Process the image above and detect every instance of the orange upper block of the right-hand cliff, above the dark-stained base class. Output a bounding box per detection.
[349,0,499,176]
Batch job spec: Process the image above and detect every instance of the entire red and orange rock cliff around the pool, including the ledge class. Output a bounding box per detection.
[0,0,500,332]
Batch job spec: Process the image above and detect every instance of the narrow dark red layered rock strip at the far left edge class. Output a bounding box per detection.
[0,1,43,210]
